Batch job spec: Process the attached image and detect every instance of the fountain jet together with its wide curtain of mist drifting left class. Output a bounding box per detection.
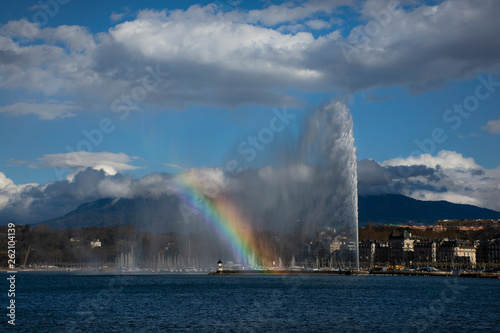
[169,102,358,267]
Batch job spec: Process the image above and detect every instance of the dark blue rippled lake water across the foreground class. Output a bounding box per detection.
[1,272,500,332]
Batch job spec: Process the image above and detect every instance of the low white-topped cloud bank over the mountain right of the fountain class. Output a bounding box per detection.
[358,151,500,211]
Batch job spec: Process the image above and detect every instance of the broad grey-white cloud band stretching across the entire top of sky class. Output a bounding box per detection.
[0,0,500,114]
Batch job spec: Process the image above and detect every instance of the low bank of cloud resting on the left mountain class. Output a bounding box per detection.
[0,168,175,224]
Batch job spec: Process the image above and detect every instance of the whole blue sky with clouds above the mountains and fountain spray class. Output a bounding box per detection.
[0,0,500,223]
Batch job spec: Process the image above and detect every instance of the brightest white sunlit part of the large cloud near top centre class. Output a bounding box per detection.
[110,6,315,79]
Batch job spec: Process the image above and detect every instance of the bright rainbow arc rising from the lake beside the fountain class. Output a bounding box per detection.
[174,172,271,264]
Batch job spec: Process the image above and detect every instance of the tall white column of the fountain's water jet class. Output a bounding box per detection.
[300,101,359,270]
